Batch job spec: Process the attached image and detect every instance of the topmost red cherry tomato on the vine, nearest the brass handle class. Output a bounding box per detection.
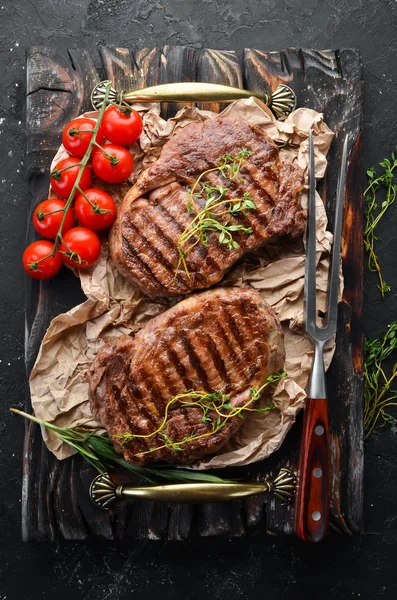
[99,106,143,146]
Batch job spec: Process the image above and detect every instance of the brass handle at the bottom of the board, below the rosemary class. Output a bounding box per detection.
[90,468,296,509]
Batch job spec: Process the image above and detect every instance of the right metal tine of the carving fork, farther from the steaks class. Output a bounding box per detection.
[326,135,349,337]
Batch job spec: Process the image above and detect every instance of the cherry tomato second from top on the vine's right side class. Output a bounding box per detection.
[92,144,134,183]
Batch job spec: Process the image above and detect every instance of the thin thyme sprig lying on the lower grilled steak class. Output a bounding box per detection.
[118,371,287,457]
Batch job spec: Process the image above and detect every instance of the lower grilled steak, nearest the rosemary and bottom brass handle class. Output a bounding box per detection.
[88,288,285,464]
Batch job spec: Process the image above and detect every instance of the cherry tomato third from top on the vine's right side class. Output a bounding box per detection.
[74,188,117,230]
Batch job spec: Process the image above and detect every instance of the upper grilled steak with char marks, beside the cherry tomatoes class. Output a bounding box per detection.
[110,116,304,296]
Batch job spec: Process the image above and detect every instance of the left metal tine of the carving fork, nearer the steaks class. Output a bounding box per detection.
[305,130,316,337]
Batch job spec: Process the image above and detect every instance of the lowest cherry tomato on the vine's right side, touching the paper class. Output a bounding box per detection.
[60,227,101,269]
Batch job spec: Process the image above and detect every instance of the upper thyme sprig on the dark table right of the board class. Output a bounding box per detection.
[363,152,397,298]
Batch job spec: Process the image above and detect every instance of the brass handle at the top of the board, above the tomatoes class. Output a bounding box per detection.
[91,80,297,119]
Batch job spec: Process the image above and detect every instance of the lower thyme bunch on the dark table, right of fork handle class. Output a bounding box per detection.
[364,321,397,438]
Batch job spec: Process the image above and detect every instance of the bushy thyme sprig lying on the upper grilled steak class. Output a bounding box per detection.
[175,148,256,277]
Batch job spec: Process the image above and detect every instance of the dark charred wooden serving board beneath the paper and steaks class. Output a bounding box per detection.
[22,46,363,540]
